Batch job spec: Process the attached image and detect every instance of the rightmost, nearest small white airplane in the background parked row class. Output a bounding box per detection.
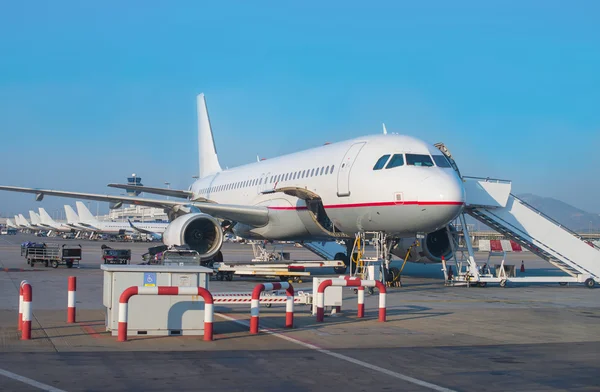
[75,201,169,238]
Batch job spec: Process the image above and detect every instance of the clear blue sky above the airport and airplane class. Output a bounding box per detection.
[0,1,600,214]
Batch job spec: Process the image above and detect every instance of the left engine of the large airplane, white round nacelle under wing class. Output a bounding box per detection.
[163,213,223,260]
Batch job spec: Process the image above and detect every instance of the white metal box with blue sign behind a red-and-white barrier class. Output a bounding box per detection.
[101,264,212,336]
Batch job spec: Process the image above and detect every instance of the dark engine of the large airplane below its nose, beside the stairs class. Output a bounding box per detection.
[392,226,458,263]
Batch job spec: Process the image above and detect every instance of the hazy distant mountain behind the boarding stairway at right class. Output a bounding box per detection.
[517,193,600,233]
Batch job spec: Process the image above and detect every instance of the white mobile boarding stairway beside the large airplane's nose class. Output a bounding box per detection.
[455,177,600,288]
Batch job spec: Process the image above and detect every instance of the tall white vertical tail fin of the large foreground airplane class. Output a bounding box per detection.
[197,94,223,178]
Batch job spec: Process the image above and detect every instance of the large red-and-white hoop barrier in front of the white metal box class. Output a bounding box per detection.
[118,286,214,342]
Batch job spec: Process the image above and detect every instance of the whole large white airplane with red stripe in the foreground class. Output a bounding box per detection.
[0,94,465,265]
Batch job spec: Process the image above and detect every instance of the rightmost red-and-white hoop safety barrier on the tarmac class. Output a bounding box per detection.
[317,276,386,322]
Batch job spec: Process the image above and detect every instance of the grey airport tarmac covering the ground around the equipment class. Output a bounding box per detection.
[0,234,600,392]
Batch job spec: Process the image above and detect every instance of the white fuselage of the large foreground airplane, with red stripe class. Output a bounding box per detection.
[190,135,465,240]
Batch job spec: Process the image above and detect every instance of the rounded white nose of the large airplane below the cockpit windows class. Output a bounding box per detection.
[418,170,465,231]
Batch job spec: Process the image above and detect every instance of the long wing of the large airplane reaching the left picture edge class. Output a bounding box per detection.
[0,185,269,227]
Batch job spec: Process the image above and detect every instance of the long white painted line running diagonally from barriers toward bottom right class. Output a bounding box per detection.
[215,313,455,392]
